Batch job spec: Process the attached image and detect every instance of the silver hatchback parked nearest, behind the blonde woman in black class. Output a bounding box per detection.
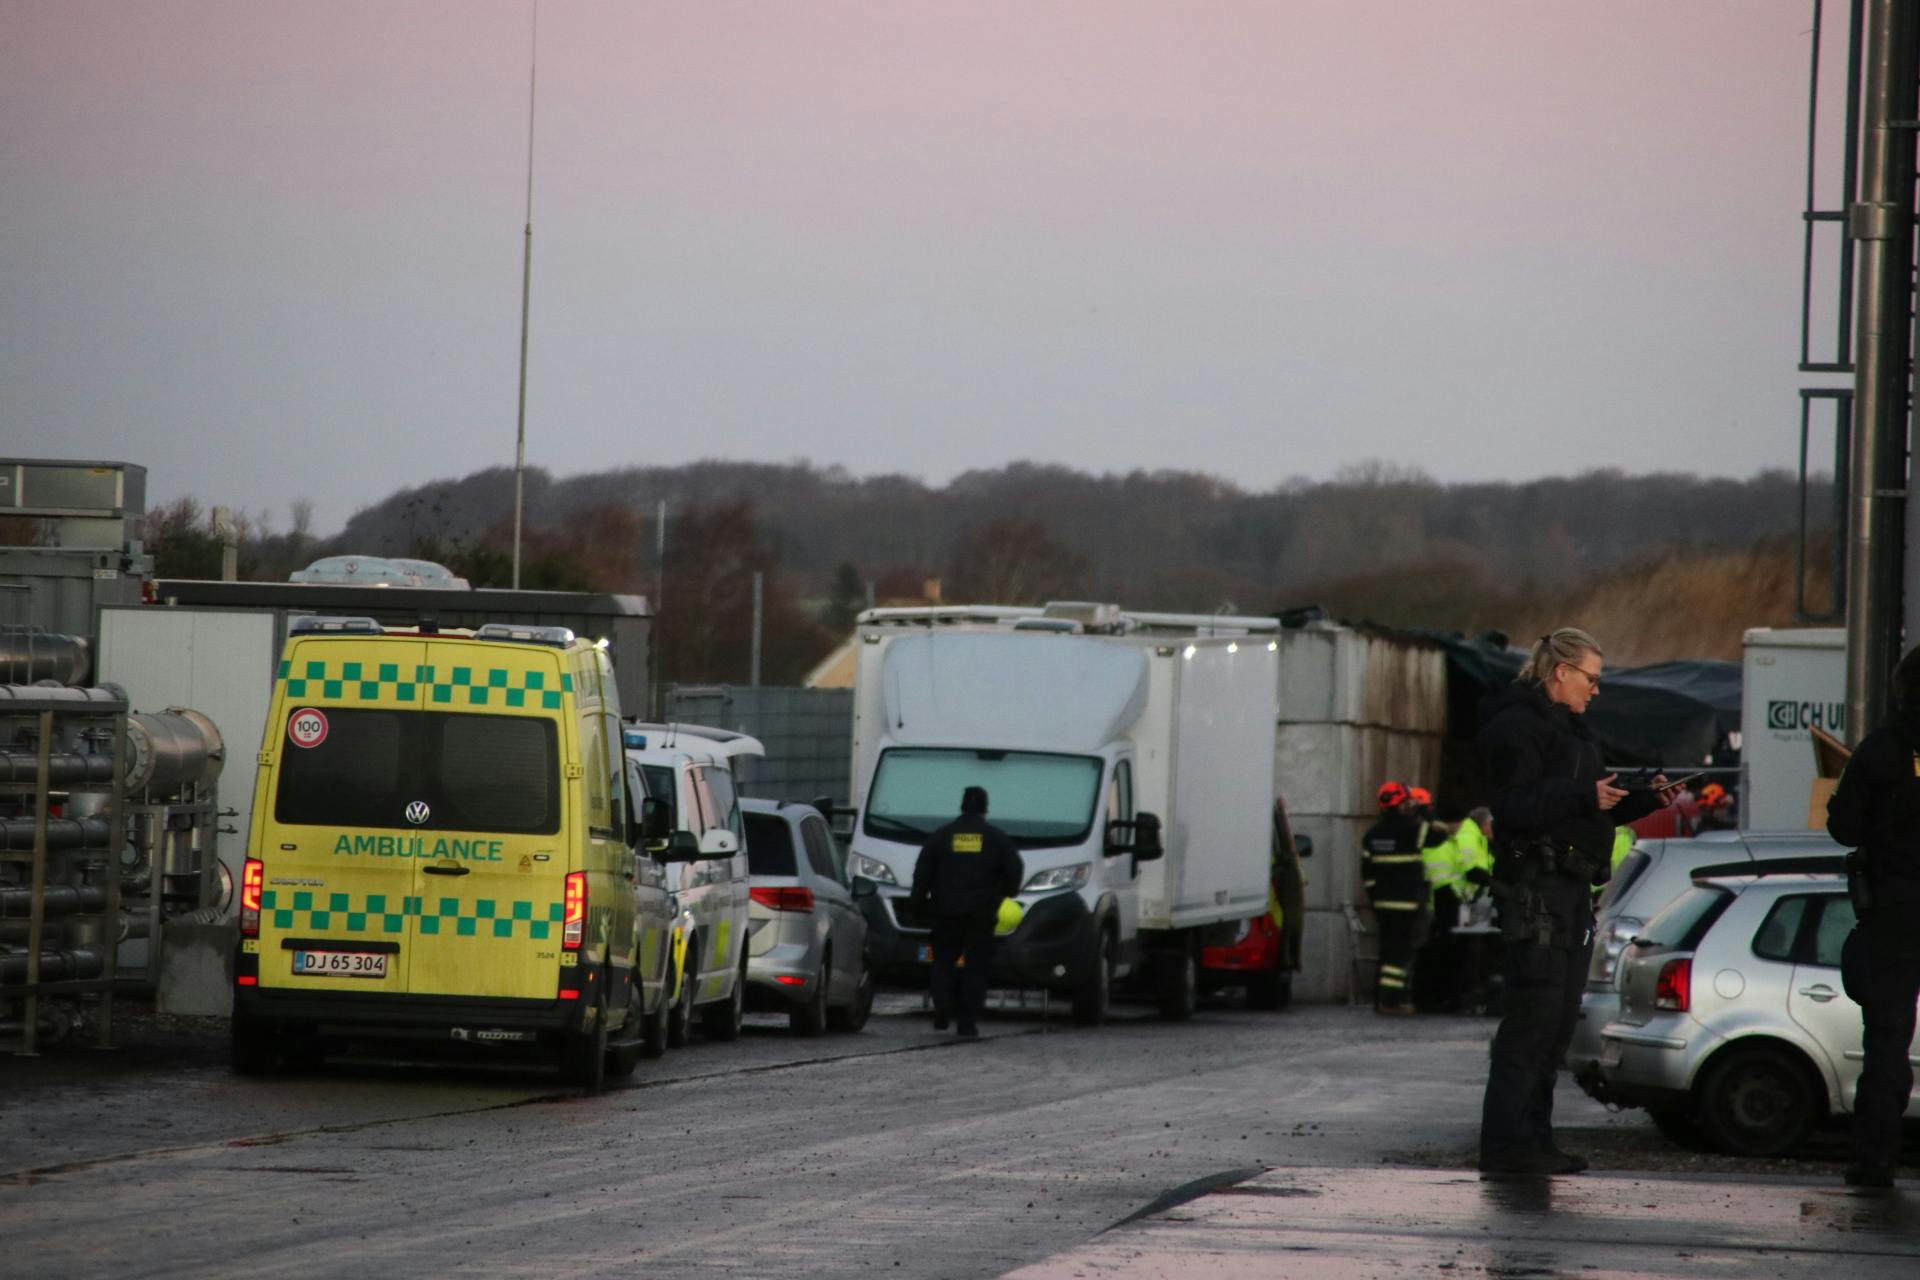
[1599,873,1920,1155]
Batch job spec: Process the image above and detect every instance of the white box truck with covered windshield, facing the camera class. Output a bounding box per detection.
[849,614,1279,1023]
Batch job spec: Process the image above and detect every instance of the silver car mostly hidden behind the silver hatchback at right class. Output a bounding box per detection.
[1565,831,1847,1102]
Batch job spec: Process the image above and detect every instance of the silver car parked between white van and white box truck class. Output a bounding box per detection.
[741,800,874,1036]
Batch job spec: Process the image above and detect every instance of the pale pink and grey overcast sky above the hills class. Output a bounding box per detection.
[0,0,1843,530]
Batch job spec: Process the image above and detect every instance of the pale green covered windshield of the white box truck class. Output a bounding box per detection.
[866,747,1100,846]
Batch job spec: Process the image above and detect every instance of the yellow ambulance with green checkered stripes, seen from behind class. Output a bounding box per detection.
[232,618,699,1088]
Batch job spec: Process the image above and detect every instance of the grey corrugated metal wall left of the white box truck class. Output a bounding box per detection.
[666,685,852,804]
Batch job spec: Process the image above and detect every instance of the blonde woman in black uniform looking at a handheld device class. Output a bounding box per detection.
[1476,628,1670,1174]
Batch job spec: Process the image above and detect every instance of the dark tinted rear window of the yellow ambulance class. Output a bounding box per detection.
[273,708,561,835]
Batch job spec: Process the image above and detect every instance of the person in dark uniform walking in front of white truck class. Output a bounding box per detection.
[912,787,1025,1036]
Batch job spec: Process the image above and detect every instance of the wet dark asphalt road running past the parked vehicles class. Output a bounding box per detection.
[0,996,1920,1278]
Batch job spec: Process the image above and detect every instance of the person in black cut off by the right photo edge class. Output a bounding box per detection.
[1826,649,1920,1186]
